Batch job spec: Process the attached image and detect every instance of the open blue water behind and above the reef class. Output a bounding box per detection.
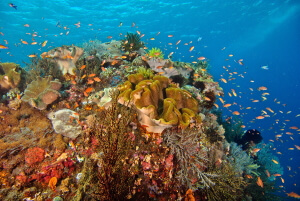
[0,0,300,199]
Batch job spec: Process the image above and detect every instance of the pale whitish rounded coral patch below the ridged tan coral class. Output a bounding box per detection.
[48,109,81,139]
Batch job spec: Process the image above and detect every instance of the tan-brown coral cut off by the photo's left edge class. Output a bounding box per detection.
[0,63,21,91]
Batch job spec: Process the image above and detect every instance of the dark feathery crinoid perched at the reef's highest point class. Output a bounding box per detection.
[122,33,144,52]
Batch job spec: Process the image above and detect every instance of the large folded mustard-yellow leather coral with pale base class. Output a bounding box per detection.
[118,73,198,133]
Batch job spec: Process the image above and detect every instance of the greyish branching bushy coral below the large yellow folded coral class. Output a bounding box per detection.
[163,128,217,190]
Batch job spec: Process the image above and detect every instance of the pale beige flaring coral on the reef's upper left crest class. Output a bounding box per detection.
[41,45,83,75]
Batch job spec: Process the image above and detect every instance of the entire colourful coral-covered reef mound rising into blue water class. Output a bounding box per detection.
[0,37,283,201]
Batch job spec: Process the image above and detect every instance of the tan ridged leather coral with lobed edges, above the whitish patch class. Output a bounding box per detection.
[21,76,62,110]
